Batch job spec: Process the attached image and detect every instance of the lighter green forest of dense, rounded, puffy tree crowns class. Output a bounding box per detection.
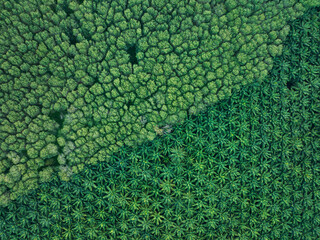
[0,0,317,204]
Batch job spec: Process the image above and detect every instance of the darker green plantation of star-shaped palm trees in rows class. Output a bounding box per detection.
[0,6,320,240]
